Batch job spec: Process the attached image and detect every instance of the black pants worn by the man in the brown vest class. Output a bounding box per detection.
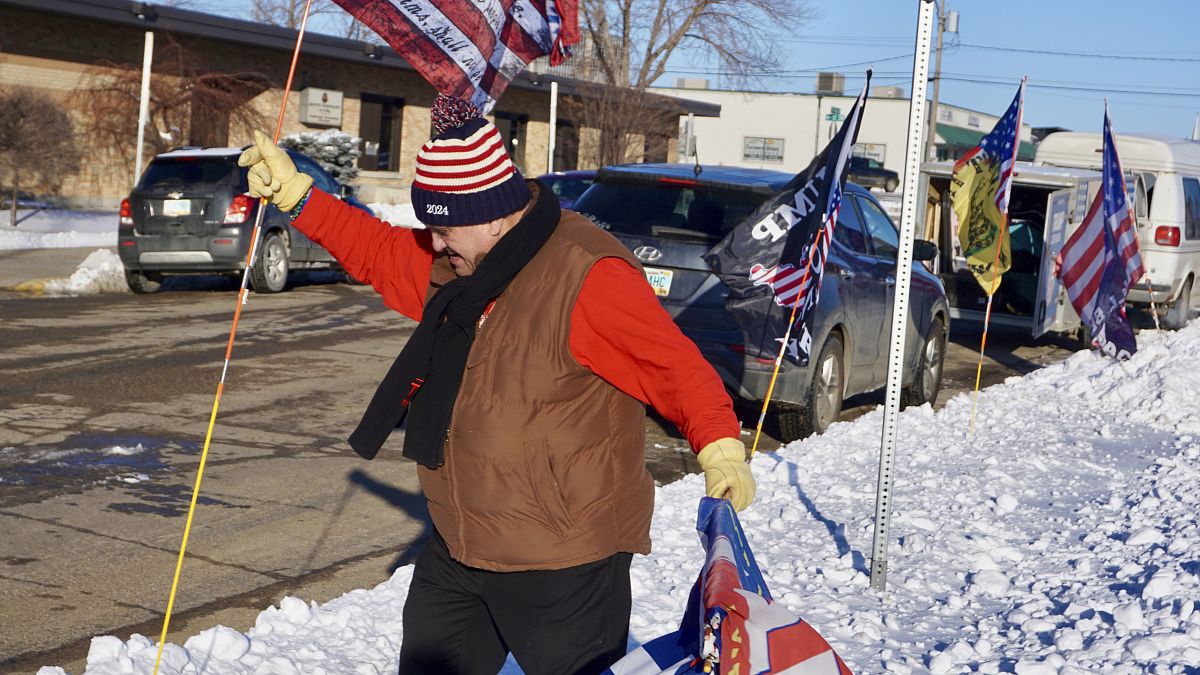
[400,532,634,675]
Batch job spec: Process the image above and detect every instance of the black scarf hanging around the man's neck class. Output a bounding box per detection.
[349,181,560,468]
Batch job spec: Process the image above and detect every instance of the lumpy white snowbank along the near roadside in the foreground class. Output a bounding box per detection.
[41,322,1200,675]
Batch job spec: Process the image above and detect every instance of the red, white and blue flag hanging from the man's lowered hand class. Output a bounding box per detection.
[605,497,851,675]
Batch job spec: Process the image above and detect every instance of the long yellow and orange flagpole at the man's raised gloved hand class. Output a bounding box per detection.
[152,0,312,675]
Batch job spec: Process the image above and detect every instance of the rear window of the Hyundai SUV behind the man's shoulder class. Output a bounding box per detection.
[575,181,767,244]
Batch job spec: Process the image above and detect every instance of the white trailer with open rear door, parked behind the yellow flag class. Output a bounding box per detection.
[920,162,1100,338]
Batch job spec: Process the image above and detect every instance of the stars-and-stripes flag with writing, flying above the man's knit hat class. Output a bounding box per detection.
[334,0,580,114]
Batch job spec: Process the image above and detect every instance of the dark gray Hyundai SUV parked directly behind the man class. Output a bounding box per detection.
[575,165,949,441]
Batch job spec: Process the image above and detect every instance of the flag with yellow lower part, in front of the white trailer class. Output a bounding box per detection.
[950,79,1025,295]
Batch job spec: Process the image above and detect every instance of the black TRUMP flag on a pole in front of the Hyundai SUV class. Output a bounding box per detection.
[704,71,871,365]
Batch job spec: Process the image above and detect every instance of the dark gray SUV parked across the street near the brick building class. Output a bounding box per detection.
[118,148,371,293]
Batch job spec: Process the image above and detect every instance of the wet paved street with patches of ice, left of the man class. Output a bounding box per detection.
[0,250,1070,673]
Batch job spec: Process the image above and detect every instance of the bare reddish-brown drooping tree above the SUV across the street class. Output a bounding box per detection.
[78,36,271,176]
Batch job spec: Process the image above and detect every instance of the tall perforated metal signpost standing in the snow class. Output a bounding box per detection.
[871,0,935,591]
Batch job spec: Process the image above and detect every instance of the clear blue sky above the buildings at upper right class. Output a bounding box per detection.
[662,0,1200,137]
